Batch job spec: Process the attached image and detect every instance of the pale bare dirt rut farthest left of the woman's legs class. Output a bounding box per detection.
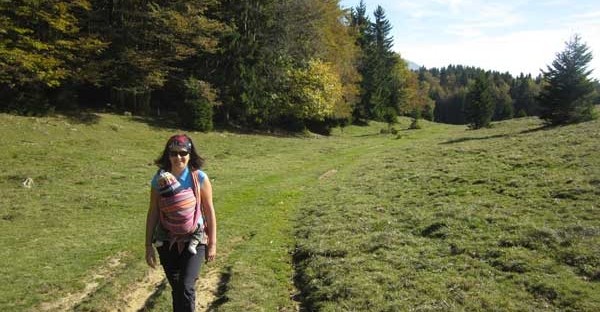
[33,253,125,311]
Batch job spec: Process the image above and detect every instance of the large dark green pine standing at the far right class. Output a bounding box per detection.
[539,35,594,125]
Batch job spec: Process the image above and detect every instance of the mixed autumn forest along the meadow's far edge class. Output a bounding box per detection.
[0,0,596,133]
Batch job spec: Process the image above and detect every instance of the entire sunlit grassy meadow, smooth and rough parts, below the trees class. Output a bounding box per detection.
[0,114,600,311]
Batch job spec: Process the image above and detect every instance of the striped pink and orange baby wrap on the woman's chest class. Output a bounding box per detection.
[158,170,207,253]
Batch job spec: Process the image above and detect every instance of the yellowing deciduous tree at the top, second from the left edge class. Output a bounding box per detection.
[90,0,224,113]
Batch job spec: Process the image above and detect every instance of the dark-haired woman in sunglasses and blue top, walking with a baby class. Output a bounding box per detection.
[146,134,217,312]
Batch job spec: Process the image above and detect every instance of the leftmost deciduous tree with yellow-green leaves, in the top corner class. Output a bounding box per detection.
[0,0,106,113]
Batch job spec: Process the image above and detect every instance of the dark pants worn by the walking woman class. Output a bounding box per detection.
[157,242,206,312]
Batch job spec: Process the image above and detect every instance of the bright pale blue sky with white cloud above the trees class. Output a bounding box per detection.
[340,0,600,80]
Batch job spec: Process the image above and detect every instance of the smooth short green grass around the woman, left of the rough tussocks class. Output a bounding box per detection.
[0,115,398,311]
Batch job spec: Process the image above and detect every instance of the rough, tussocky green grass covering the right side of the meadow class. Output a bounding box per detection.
[296,119,600,311]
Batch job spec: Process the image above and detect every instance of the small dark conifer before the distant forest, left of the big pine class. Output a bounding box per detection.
[465,74,494,129]
